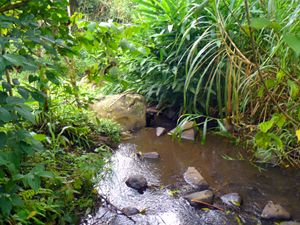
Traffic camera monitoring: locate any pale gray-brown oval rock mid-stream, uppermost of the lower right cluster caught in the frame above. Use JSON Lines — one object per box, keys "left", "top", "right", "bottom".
{"left": 184, "top": 167, "right": 208, "bottom": 191}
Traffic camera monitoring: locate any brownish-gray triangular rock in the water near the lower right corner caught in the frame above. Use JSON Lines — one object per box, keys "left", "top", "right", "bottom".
{"left": 260, "top": 201, "right": 291, "bottom": 220}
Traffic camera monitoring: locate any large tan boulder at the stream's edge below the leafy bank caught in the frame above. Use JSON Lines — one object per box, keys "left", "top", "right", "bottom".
{"left": 89, "top": 93, "right": 147, "bottom": 131}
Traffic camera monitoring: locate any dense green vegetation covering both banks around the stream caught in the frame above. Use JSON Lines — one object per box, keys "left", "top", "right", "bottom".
{"left": 0, "top": 0, "right": 300, "bottom": 224}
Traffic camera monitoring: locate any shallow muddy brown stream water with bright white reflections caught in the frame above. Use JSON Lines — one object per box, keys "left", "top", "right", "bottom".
{"left": 88, "top": 128, "right": 300, "bottom": 225}
